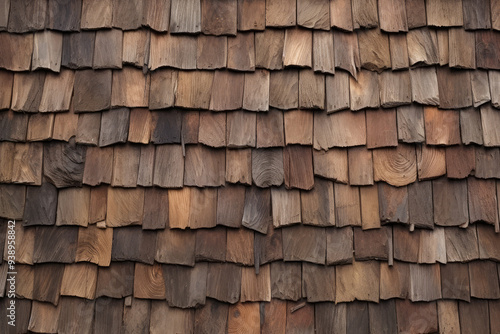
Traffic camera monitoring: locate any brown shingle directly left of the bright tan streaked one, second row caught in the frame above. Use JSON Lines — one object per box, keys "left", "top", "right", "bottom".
{"left": 255, "top": 29, "right": 285, "bottom": 70}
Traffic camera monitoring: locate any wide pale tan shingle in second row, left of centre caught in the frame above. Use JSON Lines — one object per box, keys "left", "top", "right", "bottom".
{"left": 149, "top": 32, "right": 195, "bottom": 70}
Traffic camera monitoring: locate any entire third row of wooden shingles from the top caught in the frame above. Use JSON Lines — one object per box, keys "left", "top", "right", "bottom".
{"left": 0, "top": 58, "right": 500, "bottom": 113}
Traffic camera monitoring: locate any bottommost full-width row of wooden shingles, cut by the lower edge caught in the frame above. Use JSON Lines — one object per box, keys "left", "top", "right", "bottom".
{"left": 1, "top": 297, "right": 500, "bottom": 334}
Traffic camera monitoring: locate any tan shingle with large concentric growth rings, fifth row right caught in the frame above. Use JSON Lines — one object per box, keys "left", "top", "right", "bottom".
{"left": 373, "top": 145, "right": 417, "bottom": 187}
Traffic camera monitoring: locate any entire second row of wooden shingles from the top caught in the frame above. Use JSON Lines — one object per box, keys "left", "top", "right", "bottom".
{"left": 0, "top": 24, "right": 500, "bottom": 76}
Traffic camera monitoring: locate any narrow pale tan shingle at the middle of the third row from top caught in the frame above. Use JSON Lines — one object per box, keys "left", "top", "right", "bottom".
{"left": 243, "top": 70, "right": 270, "bottom": 111}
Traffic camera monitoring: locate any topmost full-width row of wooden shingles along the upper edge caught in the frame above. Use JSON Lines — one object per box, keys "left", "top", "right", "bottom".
{"left": 0, "top": 0, "right": 500, "bottom": 35}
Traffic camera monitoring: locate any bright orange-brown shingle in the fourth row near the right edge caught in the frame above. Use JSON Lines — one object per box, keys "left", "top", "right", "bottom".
{"left": 424, "top": 107, "right": 460, "bottom": 145}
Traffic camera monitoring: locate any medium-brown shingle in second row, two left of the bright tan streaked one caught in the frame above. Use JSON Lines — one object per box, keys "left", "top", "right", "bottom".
{"left": 227, "top": 32, "right": 255, "bottom": 71}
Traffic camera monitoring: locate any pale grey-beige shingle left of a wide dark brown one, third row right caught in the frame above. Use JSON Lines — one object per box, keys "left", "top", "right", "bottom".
{"left": 410, "top": 67, "right": 439, "bottom": 105}
